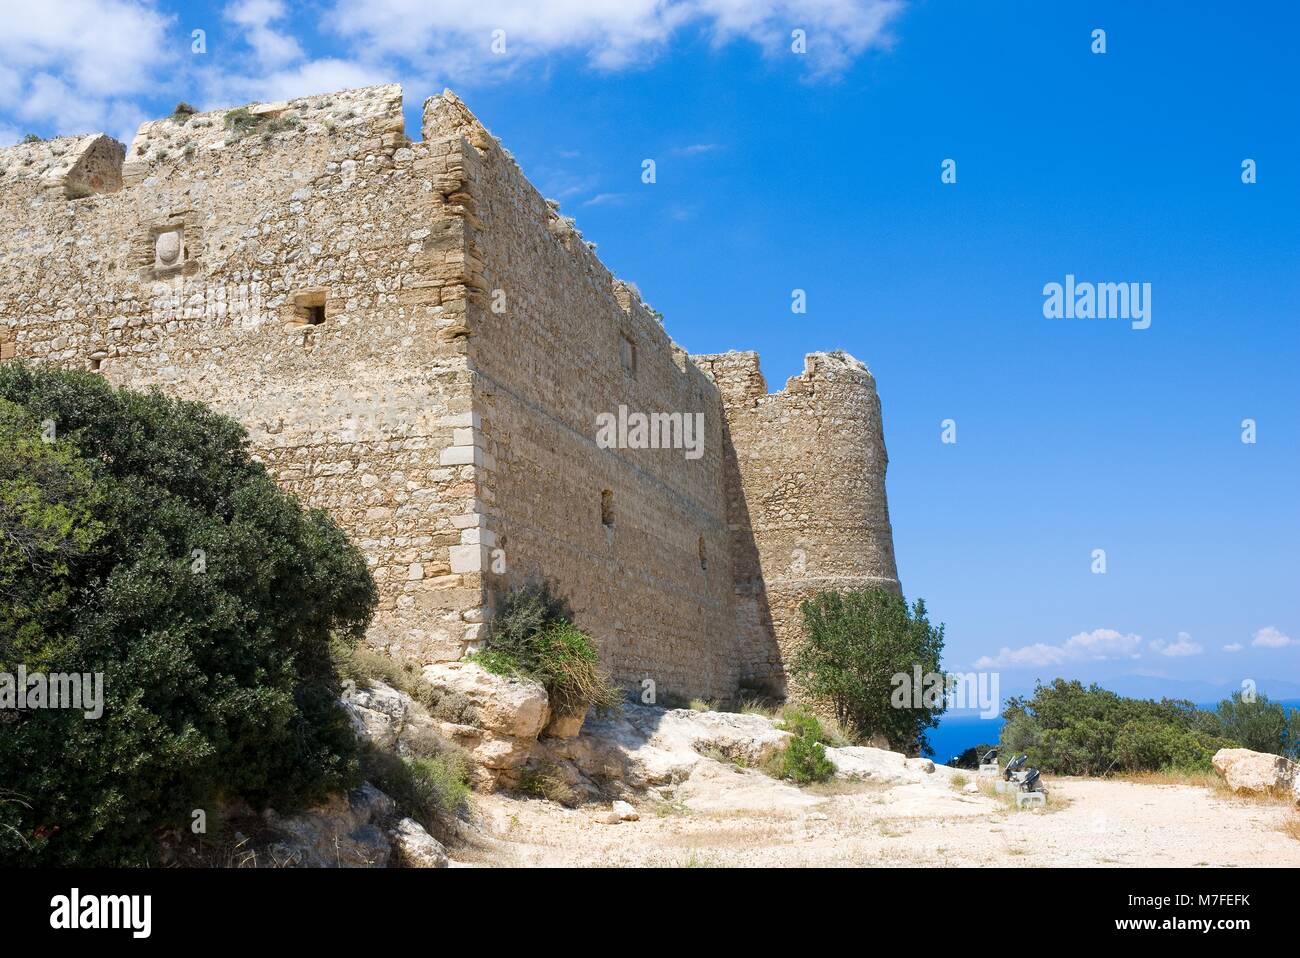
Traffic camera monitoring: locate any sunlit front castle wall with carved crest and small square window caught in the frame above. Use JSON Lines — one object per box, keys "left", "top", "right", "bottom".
{"left": 0, "top": 86, "right": 482, "bottom": 662}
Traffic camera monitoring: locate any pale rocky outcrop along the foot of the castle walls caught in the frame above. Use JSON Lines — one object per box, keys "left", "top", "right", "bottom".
{"left": 345, "top": 662, "right": 972, "bottom": 816}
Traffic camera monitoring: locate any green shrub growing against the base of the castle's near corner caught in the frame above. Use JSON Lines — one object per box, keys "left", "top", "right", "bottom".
{"left": 471, "top": 584, "right": 624, "bottom": 715}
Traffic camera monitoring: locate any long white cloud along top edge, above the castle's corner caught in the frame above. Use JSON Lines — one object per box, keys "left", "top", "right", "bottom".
{"left": 329, "top": 0, "right": 904, "bottom": 81}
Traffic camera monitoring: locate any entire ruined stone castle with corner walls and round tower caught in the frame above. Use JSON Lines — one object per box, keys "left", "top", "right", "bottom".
{"left": 0, "top": 84, "right": 898, "bottom": 699}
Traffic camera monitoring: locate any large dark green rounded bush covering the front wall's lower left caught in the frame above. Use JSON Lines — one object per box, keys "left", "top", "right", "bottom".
{"left": 0, "top": 363, "right": 377, "bottom": 864}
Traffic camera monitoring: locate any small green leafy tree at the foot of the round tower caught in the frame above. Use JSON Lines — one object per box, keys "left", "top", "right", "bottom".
{"left": 790, "top": 589, "right": 944, "bottom": 751}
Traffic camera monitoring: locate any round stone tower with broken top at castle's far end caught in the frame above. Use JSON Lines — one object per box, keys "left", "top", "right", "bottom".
{"left": 692, "top": 352, "right": 898, "bottom": 690}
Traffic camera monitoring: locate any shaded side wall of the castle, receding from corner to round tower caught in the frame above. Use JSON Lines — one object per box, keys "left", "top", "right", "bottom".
{"left": 425, "top": 94, "right": 736, "bottom": 697}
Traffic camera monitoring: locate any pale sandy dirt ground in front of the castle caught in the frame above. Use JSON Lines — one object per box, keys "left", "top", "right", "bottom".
{"left": 451, "top": 762, "right": 1300, "bottom": 868}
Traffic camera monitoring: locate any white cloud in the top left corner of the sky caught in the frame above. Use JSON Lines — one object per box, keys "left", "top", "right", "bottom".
{"left": 0, "top": 0, "right": 176, "bottom": 138}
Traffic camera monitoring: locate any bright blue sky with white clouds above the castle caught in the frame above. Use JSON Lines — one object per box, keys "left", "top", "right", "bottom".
{"left": 0, "top": 0, "right": 1300, "bottom": 701}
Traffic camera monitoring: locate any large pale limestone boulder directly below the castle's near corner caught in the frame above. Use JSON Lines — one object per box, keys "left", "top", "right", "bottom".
{"left": 421, "top": 662, "right": 551, "bottom": 740}
